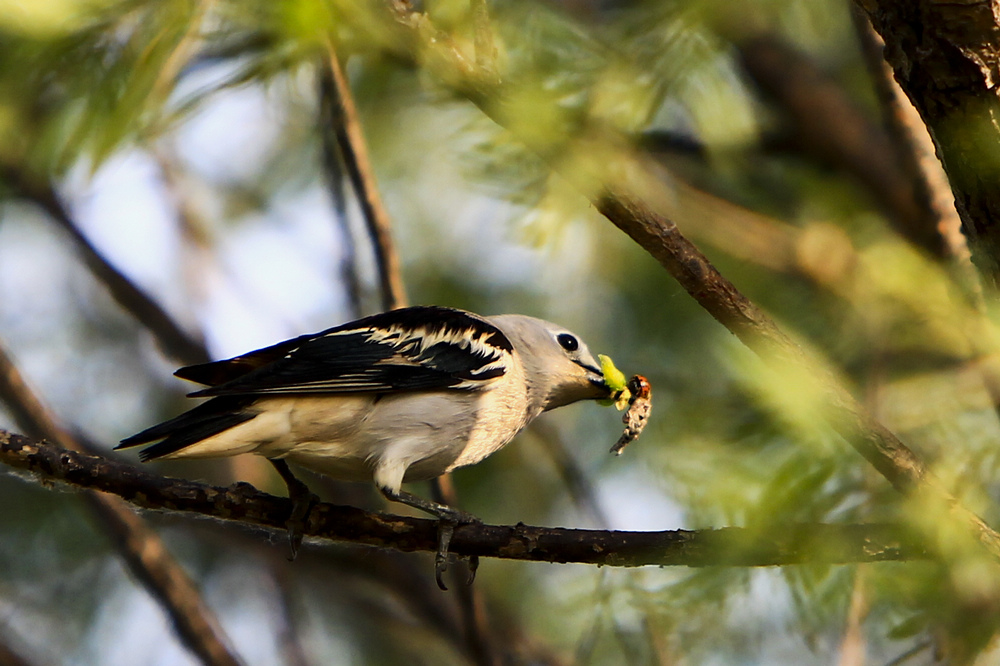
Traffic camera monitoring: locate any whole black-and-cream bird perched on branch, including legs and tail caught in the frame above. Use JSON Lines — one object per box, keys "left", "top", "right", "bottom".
{"left": 116, "top": 306, "right": 611, "bottom": 587}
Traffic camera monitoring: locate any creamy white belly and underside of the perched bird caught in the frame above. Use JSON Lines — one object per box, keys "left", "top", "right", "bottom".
{"left": 165, "top": 358, "right": 537, "bottom": 492}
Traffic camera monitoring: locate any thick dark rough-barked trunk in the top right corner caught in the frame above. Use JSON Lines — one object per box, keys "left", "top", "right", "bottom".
{"left": 859, "top": 0, "right": 1000, "bottom": 287}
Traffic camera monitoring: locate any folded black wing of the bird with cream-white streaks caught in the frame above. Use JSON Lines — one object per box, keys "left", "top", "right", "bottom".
{"left": 177, "top": 306, "right": 513, "bottom": 396}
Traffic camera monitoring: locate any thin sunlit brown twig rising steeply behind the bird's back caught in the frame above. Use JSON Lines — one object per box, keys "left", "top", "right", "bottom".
{"left": 323, "top": 44, "right": 407, "bottom": 310}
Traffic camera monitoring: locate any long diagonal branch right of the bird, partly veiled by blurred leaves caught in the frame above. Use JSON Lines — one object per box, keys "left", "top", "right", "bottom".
{"left": 376, "top": 5, "right": 1000, "bottom": 560}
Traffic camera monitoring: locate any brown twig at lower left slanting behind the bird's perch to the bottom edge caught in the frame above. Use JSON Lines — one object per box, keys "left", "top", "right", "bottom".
{"left": 0, "top": 347, "right": 240, "bottom": 666}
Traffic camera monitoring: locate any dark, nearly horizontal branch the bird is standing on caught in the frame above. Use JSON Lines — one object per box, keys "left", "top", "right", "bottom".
{"left": 0, "top": 430, "right": 929, "bottom": 567}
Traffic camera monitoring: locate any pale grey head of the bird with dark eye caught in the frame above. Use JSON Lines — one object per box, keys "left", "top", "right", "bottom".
{"left": 489, "top": 315, "right": 611, "bottom": 410}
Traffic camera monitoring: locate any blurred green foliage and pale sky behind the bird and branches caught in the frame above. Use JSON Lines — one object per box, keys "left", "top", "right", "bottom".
{"left": 0, "top": 0, "right": 1000, "bottom": 665}
